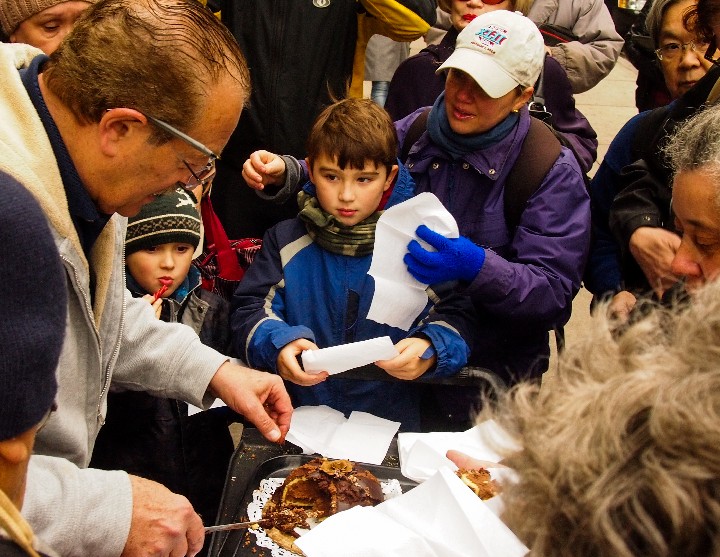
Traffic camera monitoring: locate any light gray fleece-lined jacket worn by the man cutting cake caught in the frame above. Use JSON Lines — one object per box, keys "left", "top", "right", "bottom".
{"left": 0, "top": 44, "right": 227, "bottom": 557}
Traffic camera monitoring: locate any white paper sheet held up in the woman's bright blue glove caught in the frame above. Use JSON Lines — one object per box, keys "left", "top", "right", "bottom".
{"left": 367, "top": 193, "right": 460, "bottom": 331}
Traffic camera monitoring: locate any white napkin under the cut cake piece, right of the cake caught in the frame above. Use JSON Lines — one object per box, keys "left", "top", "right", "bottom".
{"left": 398, "top": 420, "right": 520, "bottom": 482}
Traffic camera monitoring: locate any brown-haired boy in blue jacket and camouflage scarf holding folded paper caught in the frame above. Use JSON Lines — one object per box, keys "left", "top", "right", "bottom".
{"left": 231, "top": 99, "right": 472, "bottom": 430}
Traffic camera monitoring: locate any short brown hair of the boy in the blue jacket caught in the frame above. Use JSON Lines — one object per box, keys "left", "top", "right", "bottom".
{"left": 307, "top": 98, "right": 397, "bottom": 172}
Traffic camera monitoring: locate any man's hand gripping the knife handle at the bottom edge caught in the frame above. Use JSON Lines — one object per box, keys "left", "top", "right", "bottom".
{"left": 122, "top": 476, "right": 204, "bottom": 557}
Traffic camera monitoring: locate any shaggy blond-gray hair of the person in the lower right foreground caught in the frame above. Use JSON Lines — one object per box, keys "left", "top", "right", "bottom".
{"left": 481, "top": 283, "right": 720, "bottom": 557}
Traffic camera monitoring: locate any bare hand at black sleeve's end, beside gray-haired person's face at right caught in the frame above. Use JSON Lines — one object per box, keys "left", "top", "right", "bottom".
{"left": 630, "top": 226, "right": 680, "bottom": 298}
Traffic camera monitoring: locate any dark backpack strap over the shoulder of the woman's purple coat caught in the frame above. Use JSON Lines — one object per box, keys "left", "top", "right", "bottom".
{"left": 504, "top": 118, "right": 560, "bottom": 234}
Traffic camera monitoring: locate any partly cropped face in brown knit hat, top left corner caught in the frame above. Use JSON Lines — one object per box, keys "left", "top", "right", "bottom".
{"left": 0, "top": 0, "right": 96, "bottom": 56}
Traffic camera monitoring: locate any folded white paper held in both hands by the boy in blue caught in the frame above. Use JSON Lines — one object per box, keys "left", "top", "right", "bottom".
{"left": 301, "top": 336, "right": 399, "bottom": 375}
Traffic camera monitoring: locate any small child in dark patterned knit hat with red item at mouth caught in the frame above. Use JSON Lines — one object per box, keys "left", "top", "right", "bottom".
{"left": 91, "top": 188, "right": 234, "bottom": 536}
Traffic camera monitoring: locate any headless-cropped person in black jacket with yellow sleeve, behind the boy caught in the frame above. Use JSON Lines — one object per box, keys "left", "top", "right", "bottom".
{"left": 205, "top": 0, "right": 435, "bottom": 238}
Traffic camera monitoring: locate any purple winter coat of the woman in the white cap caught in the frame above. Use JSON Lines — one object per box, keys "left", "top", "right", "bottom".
{"left": 395, "top": 107, "right": 590, "bottom": 383}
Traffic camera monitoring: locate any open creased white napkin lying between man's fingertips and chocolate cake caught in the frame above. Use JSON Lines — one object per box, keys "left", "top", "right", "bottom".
{"left": 286, "top": 406, "right": 400, "bottom": 464}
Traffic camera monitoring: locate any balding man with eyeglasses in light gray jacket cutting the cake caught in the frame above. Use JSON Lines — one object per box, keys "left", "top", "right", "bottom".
{"left": 0, "top": 0, "right": 292, "bottom": 557}
